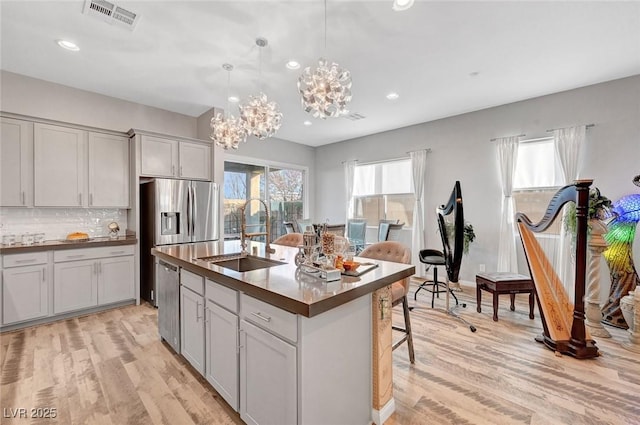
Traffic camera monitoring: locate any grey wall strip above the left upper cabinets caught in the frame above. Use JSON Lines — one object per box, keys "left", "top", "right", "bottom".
{"left": 0, "top": 71, "right": 196, "bottom": 138}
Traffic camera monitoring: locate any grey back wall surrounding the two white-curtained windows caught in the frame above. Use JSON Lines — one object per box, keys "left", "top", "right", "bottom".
{"left": 316, "top": 76, "right": 640, "bottom": 280}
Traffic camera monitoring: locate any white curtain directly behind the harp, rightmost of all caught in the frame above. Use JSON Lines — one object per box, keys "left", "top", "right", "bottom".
{"left": 553, "top": 125, "right": 587, "bottom": 295}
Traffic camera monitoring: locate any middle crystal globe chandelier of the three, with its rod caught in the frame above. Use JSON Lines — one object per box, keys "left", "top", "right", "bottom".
{"left": 240, "top": 38, "right": 282, "bottom": 140}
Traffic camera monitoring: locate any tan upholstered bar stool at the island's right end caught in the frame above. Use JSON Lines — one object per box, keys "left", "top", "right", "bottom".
{"left": 359, "top": 241, "right": 415, "bottom": 363}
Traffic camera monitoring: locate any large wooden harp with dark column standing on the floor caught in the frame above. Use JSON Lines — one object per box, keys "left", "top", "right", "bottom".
{"left": 516, "top": 180, "right": 598, "bottom": 359}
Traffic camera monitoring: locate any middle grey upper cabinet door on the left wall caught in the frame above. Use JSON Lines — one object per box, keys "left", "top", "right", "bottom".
{"left": 34, "top": 123, "right": 87, "bottom": 207}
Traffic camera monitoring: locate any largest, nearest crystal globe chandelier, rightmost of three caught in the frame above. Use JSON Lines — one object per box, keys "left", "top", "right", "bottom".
{"left": 298, "top": 0, "right": 351, "bottom": 119}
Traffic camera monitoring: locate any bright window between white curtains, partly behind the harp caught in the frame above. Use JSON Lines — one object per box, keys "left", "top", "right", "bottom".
{"left": 513, "top": 137, "right": 564, "bottom": 235}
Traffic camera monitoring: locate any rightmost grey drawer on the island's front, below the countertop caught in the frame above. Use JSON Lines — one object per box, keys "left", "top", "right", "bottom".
{"left": 240, "top": 294, "right": 298, "bottom": 342}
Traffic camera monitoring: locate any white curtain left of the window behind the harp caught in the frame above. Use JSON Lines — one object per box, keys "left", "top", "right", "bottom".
{"left": 496, "top": 136, "right": 520, "bottom": 273}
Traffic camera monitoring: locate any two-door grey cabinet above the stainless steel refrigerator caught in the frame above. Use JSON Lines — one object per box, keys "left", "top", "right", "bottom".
{"left": 140, "top": 135, "right": 212, "bottom": 180}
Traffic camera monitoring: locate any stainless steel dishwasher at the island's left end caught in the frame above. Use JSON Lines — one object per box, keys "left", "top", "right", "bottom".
{"left": 156, "top": 260, "right": 180, "bottom": 353}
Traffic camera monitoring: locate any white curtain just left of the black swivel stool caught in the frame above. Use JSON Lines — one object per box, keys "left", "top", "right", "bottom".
{"left": 409, "top": 149, "right": 428, "bottom": 275}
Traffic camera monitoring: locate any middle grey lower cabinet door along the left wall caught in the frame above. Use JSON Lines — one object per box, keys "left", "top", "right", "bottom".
{"left": 53, "top": 260, "right": 98, "bottom": 314}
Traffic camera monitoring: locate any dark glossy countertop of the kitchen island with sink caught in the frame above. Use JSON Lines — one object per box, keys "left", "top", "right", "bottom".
{"left": 151, "top": 241, "right": 415, "bottom": 317}
